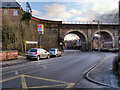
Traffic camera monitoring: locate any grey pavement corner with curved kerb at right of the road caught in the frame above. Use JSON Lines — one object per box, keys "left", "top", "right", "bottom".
{"left": 86, "top": 53, "right": 120, "bottom": 89}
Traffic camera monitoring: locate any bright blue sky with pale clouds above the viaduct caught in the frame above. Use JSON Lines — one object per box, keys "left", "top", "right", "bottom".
{"left": 17, "top": 0, "right": 119, "bottom": 21}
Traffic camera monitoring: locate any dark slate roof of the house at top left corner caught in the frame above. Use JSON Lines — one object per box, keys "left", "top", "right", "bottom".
{"left": 2, "top": 2, "right": 21, "bottom": 8}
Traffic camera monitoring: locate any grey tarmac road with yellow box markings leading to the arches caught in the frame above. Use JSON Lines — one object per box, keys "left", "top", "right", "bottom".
{"left": 0, "top": 51, "right": 115, "bottom": 88}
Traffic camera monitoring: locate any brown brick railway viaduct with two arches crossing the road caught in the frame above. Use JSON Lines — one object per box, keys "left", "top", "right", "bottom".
{"left": 59, "top": 23, "right": 119, "bottom": 50}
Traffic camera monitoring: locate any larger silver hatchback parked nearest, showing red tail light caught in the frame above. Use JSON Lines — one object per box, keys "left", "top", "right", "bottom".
{"left": 26, "top": 48, "right": 50, "bottom": 60}
